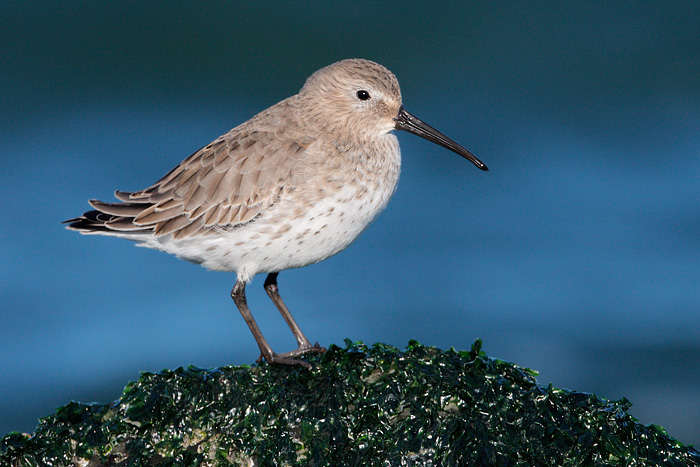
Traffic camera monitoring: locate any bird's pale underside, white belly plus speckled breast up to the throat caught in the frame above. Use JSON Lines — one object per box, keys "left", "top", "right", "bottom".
{"left": 136, "top": 134, "right": 401, "bottom": 281}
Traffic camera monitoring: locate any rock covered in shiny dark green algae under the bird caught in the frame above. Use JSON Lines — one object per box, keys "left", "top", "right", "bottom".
{"left": 0, "top": 341, "right": 700, "bottom": 466}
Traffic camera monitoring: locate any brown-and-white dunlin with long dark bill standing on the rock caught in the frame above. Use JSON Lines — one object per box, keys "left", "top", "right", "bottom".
{"left": 66, "top": 59, "right": 487, "bottom": 367}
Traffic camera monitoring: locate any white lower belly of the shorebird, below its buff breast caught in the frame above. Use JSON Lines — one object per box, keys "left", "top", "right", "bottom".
{"left": 143, "top": 169, "right": 398, "bottom": 281}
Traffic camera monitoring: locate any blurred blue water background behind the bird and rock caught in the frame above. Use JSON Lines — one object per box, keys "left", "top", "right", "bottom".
{"left": 0, "top": 1, "right": 700, "bottom": 444}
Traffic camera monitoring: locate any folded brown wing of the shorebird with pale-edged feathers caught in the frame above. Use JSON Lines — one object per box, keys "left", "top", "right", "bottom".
{"left": 71, "top": 101, "right": 312, "bottom": 238}
